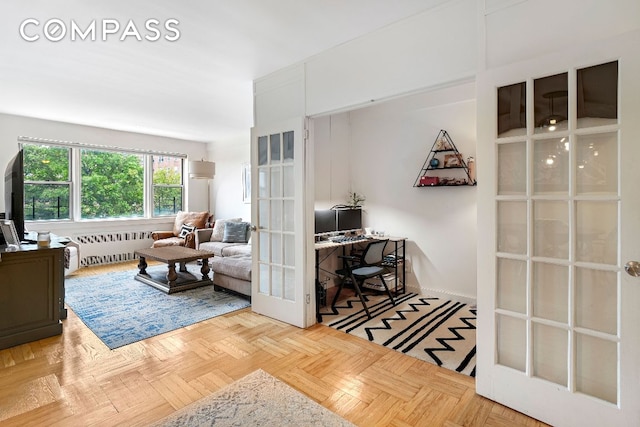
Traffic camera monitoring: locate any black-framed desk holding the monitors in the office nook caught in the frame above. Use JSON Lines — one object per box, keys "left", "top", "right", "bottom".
{"left": 315, "top": 237, "right": 407, "bottom": 323}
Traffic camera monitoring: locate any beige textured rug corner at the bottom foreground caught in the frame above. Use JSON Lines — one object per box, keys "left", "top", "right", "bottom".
{"left": 153, "top": 369, "right": 354, "bottom": 427}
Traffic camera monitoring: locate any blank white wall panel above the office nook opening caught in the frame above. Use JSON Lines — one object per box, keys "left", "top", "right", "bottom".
{"left": 305, "top": 0, "right": 478, "bottom": 115}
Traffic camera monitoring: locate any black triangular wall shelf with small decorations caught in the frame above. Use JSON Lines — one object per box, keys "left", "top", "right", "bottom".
{"left": 413, "top": 130, "right": 476, "bottom": 187}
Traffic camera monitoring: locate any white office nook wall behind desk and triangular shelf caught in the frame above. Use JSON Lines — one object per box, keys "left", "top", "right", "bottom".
{"left": 314, "top": 83, "right": 477, "bottom": 301}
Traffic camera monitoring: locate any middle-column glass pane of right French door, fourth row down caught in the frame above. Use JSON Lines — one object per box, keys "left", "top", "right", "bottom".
{"left": 532, "top": 262, "right": 569, "bottom": 324}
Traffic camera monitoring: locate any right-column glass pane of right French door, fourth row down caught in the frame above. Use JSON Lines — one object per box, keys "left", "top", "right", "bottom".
{"left": 575, "top": 268, "right": 618, "bottom": 335}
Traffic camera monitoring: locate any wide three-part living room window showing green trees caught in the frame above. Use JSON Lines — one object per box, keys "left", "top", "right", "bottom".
{"left": 22, "top": 140, "right": 184, "bottom": 221}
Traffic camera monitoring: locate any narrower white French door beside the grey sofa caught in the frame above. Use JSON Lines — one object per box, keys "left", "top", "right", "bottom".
{"left": 251, "top": 119, "right": 311, "bottom": 327}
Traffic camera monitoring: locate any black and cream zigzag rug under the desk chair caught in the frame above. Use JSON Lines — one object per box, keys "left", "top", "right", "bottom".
{"left": 322, "top": 293, "right": 476, "bottom": 377}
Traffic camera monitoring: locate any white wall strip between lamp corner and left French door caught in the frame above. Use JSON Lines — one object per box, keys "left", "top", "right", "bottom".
{"left": 209, "top": 132, "right": 251, "bottom": 221}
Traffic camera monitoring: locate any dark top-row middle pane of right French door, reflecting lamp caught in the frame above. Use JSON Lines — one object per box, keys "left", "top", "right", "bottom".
{"left": 533, "top": 73, "right": 569, "bottom": 133}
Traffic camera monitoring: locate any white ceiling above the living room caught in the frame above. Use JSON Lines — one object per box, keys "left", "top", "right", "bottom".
{"left": 0, "top": 0, "right": 449, "bottom": 141}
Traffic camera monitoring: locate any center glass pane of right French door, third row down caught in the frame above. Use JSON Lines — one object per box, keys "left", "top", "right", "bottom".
{"left": 533, "top": 200, "right": 569, "bottom": 259}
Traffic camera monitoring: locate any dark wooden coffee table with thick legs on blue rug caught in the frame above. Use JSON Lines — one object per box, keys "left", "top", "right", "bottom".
{"left": 134, "top": 246, "right": 213, "bottom": 294}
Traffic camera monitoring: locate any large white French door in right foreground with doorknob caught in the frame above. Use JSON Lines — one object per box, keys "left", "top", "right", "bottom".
{"left": 476, "top": 32, "right": 640, "bottom": 426}
